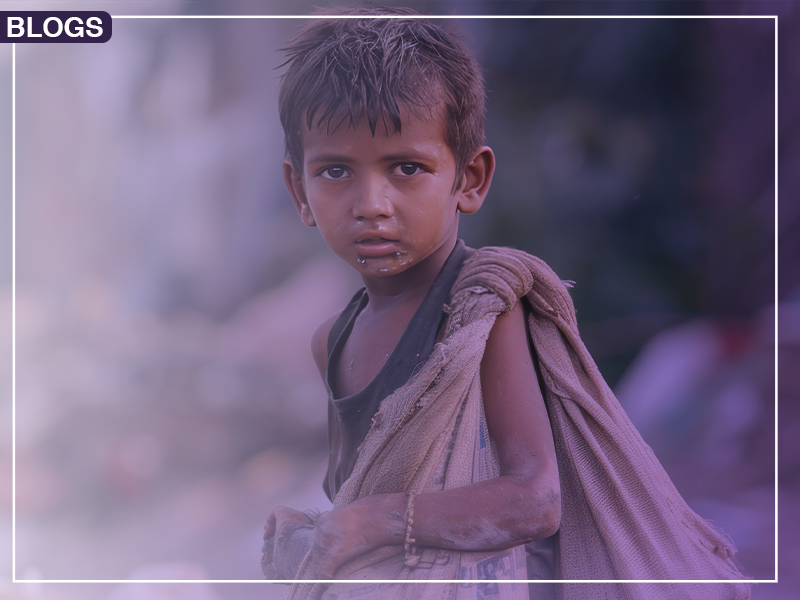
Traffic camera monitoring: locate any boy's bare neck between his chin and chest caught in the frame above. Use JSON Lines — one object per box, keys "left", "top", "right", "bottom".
{"left": 363, "top": 231, "right": 458, "bottom": 312}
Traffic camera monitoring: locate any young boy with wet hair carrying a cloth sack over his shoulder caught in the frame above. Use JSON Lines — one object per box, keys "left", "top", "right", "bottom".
{"left": 262, "top": 9, "right": 749, "bottom": 599}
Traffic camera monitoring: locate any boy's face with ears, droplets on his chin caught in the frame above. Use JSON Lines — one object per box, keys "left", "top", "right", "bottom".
{"left": 284, "top": 111, "right": 494, "bottom": 277}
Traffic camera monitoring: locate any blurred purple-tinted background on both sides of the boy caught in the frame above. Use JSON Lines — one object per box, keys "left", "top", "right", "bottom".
{"left": 0, "top": 1, "right": 800, "bottom": 600}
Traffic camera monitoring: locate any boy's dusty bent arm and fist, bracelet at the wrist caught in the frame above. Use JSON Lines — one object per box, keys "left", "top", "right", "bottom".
{"left": 284, "top": 304, "right": 561, "bottom": 579}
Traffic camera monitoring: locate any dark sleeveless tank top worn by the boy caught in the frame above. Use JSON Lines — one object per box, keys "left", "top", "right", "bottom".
{"left": 322, "top": 240, "right": 472, "bottom": 501}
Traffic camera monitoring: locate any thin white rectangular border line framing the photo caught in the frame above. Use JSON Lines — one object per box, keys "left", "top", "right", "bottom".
{"left": 11, "top": 15, "right": 778, "bottom": 584}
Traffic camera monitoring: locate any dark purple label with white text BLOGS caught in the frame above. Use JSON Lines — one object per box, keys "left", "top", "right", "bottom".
{"left": 0, "top": 10, "right": 111, "bottom": 44}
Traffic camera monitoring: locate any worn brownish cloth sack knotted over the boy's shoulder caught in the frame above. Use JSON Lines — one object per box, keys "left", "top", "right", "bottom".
{"left": 290, "top": 248, "right": 749, "bottom": 600}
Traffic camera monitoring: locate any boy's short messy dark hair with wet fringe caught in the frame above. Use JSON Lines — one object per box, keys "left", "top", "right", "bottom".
{"left": 278, "top": 8, "right": 486, "bottom": 187}
